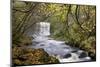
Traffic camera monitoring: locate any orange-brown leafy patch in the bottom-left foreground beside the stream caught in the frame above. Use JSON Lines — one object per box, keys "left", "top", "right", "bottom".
{"left": 13, "top": 47, "right": 59, "bottom": 65}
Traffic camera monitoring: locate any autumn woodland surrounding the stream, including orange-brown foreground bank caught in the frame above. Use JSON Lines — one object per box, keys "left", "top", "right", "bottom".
{"left": 11, "top": 0, "right": 96, "bottom": 65}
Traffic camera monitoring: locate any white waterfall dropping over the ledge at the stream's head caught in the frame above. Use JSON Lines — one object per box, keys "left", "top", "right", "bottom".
{"left": 33, "top": 22, "right": 50, "bottom": 42}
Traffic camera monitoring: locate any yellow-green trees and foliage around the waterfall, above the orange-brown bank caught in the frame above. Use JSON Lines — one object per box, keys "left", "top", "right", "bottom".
{"left": 12, "top": 1, "right": 96, "bottom": 63}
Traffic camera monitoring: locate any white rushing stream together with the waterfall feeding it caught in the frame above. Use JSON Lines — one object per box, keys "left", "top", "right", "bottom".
{"left": 31, "top": 22, "right": 91, "bottom": 63}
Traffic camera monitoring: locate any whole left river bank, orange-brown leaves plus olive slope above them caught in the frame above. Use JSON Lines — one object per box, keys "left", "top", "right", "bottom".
{"left": 12, "top": 36, "right": 59, "bottom": 66}
